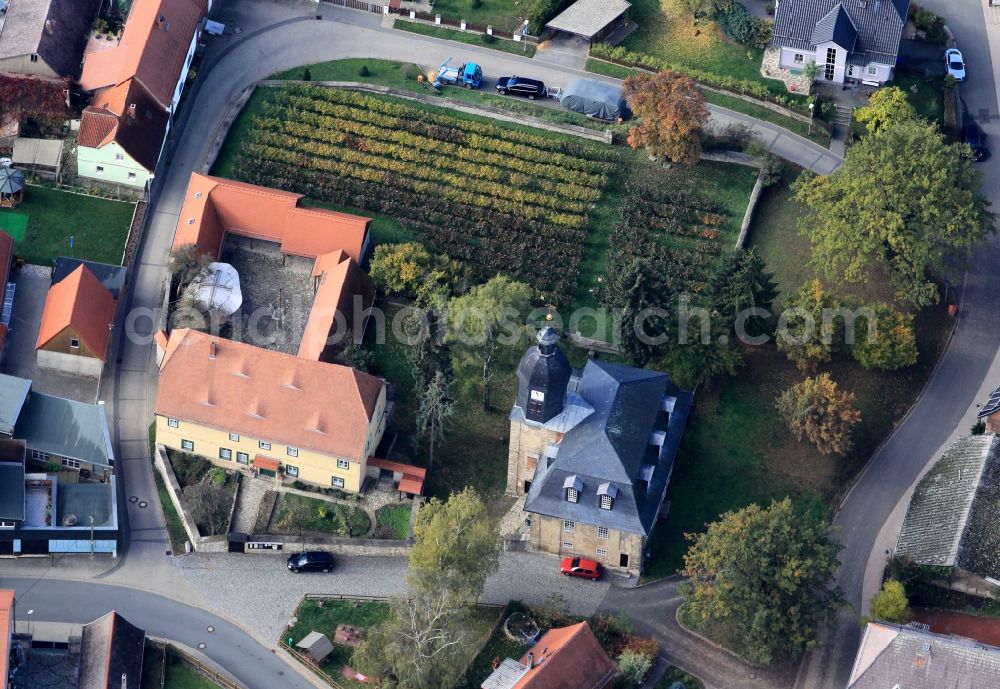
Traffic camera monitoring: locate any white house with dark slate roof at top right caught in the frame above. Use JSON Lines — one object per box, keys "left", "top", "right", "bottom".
{"left": 771, "top": 0, "right": 910, "bottom": 85}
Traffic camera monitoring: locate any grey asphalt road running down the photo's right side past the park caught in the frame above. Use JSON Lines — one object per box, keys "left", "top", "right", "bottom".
{"left": 796, "top": 0, "right": 1000, "bottom": 689}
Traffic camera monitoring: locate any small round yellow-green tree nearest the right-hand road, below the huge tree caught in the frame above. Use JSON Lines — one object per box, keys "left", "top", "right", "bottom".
{"left": 851, "top": 302, "right": 917, "bottom": 371}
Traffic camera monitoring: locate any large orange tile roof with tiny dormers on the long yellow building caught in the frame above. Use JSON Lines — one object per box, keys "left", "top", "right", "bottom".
{"left": 156, "top": 329, "right": 383, "bottom": 462}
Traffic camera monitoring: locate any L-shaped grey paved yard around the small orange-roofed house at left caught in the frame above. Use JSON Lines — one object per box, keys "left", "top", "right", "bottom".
{"left": 0, "top": 265, "right": 98, "bottom": 402}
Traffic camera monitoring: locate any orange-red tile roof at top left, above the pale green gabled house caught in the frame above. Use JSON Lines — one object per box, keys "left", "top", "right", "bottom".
{"left": 80, "top": 0, "right": 205, "bottom": 108}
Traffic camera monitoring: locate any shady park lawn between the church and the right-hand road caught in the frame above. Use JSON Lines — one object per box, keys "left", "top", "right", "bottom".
{"left": 644, "top": 168, "right": 951, "bottom": 579}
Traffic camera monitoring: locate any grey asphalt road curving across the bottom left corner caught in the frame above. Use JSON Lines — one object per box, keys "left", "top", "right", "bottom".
{"left": 0, "top": 577, "right": 314, "bottom": 689}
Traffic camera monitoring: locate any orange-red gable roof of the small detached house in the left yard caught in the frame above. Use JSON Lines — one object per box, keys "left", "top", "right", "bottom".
{"left": 35, "top": 264, "right": 115, "bottom": 361}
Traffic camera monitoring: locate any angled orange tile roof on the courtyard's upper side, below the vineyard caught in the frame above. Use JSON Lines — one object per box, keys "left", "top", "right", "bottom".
{"left": 173, "top": 173, "right": 370, "bottom": 263}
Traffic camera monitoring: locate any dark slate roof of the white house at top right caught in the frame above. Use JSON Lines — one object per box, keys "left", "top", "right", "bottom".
{"left": 771, "top": 0, "right": 910, "bottom": 65}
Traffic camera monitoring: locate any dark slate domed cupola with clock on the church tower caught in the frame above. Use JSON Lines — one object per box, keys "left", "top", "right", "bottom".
{"left": 517, "top": 326, "right": 573, "bottom": 423}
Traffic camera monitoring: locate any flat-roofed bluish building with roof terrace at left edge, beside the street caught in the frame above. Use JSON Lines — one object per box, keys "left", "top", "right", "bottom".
{"left": 0, "top": 438, "right": 120, "bottom": 555}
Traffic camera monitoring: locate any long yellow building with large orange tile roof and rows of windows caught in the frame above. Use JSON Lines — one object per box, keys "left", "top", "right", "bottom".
{"left": 156, "top": 329, "right": 386, "bottom": 492}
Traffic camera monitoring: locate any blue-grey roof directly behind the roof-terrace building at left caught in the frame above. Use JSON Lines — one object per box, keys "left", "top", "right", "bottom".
{"left": 16, "top": 392, "right": 114, "bottom": 467}
